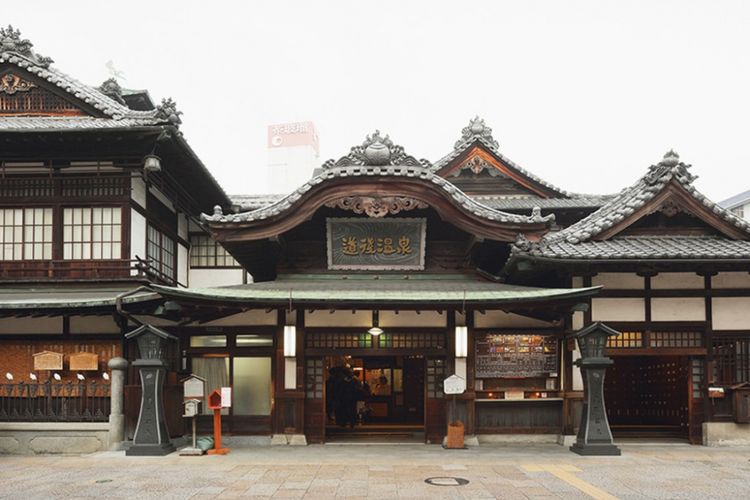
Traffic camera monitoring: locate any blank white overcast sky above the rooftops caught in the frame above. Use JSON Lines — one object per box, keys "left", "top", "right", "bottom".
{"left": 3, "top": 0, "right": 750, "bottom": 201}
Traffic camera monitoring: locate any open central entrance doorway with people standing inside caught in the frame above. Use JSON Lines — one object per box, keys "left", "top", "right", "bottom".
{"left": 324, "top": 355, "right": 425, "bottom": 443}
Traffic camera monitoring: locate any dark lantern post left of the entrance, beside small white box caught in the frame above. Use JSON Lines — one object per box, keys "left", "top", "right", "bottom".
{"left": 125, "top": 325, "right": 177, "bottom": 456}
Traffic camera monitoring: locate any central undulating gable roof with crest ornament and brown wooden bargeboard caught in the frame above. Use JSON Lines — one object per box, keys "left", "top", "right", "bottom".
{"left": 201, "top": 131, "right": 554, "bottom": 241}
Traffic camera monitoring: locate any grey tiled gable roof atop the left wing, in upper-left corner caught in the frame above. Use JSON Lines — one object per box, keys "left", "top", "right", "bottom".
{"left": 0, "top": 26, "right": 179, "bottom": 130}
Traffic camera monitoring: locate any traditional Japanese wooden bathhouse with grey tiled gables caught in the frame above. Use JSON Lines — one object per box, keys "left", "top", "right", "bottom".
{"left": 0, "top": 25, "right": 750, "bottom": 452}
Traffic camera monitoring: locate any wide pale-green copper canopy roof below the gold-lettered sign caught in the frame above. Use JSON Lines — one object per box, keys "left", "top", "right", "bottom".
{"left": 151, "top": 275, "right": 600, "bottom": 304}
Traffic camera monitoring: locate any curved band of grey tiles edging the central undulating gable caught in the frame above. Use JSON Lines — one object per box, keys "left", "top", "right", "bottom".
{"left": 206, "top": 162, "right": 554, "bottom": 224}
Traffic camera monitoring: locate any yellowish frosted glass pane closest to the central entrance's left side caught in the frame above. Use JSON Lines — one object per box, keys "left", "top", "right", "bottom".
{"left": 232, "top": 357, "right": 271, "bottom": 415}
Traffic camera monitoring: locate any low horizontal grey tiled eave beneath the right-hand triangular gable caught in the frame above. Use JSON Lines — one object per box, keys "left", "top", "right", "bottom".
{"left": 524, "top": 236, "right": 750, "bottom": 260}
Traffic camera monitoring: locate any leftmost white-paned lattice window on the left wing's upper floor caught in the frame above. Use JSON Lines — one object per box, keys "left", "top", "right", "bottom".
{"left": 0, "top": 208, "right": 52, "bottom": 260}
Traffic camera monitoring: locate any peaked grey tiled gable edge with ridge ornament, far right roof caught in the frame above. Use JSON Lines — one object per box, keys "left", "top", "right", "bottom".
{"left": 543, "top": 151, "right": 750, "bottom": 244}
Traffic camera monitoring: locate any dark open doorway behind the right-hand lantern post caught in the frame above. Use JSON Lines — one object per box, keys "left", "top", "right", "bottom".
{"left": 604, "top": 356, "right": 692, "bottom": 439}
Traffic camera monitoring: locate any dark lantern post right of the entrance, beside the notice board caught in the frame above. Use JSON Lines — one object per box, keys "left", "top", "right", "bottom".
{"left": 568, "top": 321, "right": 620, "bottom": 455}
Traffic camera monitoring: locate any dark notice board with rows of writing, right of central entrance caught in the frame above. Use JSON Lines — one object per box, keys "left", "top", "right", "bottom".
{"left": 475, "top": 333, "right": 559, "bottom": 378}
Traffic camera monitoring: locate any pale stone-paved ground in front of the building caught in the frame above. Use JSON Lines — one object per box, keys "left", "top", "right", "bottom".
{"left": 0, "top": 445, "right": 750, "bottom": 500}
